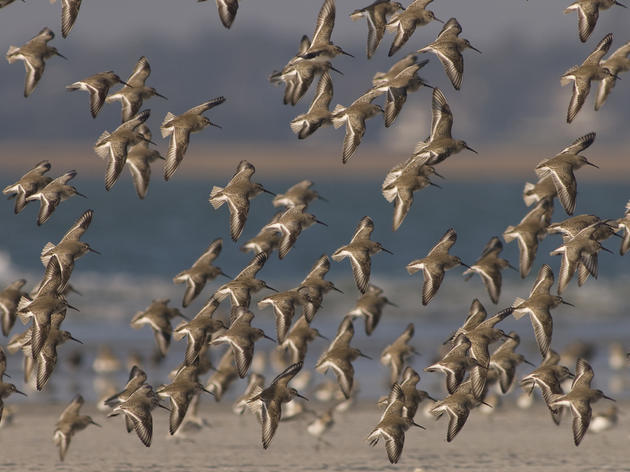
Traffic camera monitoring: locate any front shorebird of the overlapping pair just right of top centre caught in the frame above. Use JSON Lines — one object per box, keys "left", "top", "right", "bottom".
{"left": 366, "top": 55, "right": 432, "bottom": 128}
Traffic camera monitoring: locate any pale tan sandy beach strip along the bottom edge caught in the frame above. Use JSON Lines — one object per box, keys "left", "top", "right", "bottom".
{"left": 0, "top": 402, "right": 630, "bottom": 472}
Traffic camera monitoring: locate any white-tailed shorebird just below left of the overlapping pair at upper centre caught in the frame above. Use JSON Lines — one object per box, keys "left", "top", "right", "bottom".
{"left": 331, "top": 93, "right": 385, "bottom": 164}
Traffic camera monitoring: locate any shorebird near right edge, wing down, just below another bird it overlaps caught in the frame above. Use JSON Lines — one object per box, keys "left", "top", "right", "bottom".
{"left": 550, "top": 222, "right": 612, "bottom": 295}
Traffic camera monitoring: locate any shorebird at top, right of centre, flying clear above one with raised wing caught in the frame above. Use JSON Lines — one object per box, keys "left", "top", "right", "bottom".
{"left": 418, "top": 18, "right": 481, "bottom": 90}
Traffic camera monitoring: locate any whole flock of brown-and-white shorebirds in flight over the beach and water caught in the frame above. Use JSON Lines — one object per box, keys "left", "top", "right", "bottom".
{"left": 0, "top": 0, "right": 630, "bottom": 463}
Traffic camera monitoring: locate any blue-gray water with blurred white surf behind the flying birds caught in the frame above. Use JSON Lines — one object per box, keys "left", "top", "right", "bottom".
{"left": 0, "top": 176, "right": 630, "bottom": 401}
